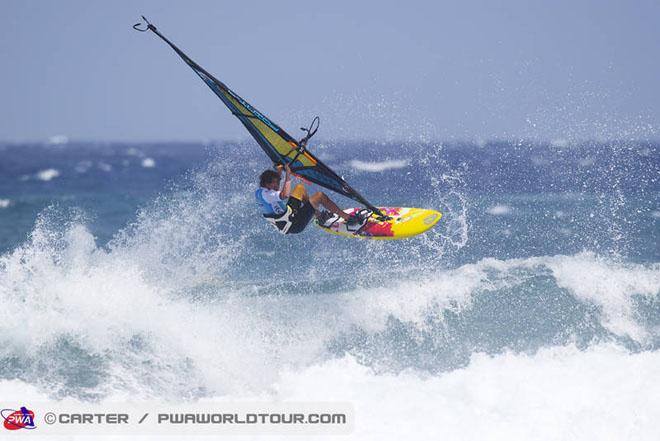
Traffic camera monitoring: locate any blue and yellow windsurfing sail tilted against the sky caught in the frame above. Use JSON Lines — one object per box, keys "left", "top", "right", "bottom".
{"left": 141, "top": 17, "right": 380, "bottom": 214}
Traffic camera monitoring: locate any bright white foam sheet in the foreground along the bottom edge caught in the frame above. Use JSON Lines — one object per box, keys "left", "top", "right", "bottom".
{"left": 0, "top": 345, "right": 660, "bottom": 441}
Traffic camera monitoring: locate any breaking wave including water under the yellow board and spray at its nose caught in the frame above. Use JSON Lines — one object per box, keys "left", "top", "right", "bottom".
{"left": 0, "top": 151, "right": 660, "bottom": 416}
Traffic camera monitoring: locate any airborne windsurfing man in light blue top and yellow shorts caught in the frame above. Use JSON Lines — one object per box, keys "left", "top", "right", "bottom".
{"left": 255, "top": 164, "right": 367, "bottom": 234}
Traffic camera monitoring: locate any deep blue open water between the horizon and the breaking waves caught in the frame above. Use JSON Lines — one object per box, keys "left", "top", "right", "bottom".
{"left": 0, "top": 142, "right": 660, "bottom": 261}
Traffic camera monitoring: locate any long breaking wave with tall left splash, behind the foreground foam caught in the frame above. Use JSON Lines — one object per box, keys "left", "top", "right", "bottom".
{"left": 0, "top": 208, "right": 660, "bottom": 399}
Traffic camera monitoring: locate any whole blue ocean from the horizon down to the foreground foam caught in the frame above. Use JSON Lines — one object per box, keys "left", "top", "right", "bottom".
{"left": 0, "top": 141, "right": 660, "bottom": 435}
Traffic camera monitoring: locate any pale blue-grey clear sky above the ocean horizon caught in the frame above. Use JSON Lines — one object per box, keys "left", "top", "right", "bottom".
{"left": 0, "top": 0, "right": 660, "bottom": 142}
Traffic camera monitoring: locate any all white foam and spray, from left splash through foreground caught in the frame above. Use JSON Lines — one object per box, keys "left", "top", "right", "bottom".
{"left": 0, "top": 164, "right": 660, "bottom": 439}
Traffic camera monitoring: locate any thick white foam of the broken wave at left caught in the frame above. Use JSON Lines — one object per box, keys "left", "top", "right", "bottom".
{"left": 0, "top": 218, "right": 276, "bottom": 394}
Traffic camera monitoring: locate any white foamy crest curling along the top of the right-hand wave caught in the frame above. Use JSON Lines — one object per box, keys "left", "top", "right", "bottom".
{"left": 342, "top": 253, "right": 660, "bottom": 344}
